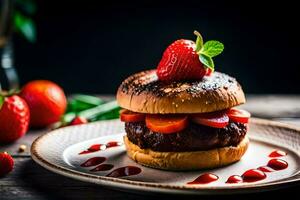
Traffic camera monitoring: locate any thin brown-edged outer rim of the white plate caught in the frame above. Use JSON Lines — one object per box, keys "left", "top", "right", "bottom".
{"left": 30, "top": 118, "right": 300, "bottom": 195}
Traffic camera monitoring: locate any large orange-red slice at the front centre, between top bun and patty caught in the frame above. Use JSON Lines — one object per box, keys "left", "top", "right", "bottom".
{"left": 146, "top": 115, "right": 188, "bottom": 134}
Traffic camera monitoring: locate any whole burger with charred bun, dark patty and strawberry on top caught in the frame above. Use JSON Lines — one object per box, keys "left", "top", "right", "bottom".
{"left": 117, "top": 32, "right": 250, "bottom": 170}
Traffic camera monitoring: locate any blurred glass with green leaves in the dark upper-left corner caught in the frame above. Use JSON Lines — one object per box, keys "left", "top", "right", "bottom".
{"left": 0, "top": 0, "right": 36, "bottom": 90}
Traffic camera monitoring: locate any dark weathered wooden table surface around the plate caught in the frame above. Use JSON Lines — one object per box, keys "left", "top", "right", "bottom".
{"left": 0, "top": 95, "right": 300, "bottom": 200}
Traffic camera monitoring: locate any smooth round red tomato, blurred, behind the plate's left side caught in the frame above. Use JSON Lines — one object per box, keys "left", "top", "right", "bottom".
{"left": 20, "top": 80, "right": 67, "bottom": 127}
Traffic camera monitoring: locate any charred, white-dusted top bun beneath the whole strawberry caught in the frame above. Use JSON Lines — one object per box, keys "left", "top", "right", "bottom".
{"left": 117, "top": 70, "right": 245, "bottom": 114}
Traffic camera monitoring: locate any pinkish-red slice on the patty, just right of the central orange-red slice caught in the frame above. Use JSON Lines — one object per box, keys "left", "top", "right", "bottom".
{"left": 191, "top": 112, "right": 229, "bottom": 128}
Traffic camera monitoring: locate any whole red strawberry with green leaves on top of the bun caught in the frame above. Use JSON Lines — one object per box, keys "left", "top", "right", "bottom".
{"left": 156, "top": 31, "right": 224, "bottom": 81}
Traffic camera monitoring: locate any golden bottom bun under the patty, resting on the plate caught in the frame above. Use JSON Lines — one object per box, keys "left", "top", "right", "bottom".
{"left": 124, "top": 136, "right": 249, "bottom": 170}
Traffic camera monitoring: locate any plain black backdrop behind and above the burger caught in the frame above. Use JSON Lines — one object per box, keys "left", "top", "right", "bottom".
{"left": 15, "top": 0, "right": 300, "bottom": 93}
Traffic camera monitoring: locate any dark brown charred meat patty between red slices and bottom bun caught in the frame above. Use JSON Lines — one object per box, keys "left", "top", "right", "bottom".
{"left": 125, "top": 122, "right": 247, "bottom": 152}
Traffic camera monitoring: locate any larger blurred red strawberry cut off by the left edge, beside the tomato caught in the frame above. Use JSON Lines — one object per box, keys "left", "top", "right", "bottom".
{"left": 0, "top": 94, "right": 30, "bottom": 143}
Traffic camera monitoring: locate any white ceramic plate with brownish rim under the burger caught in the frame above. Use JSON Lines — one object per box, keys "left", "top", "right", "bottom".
{"left": 31, "top": 119, "right": 300, "bottom": 194}
